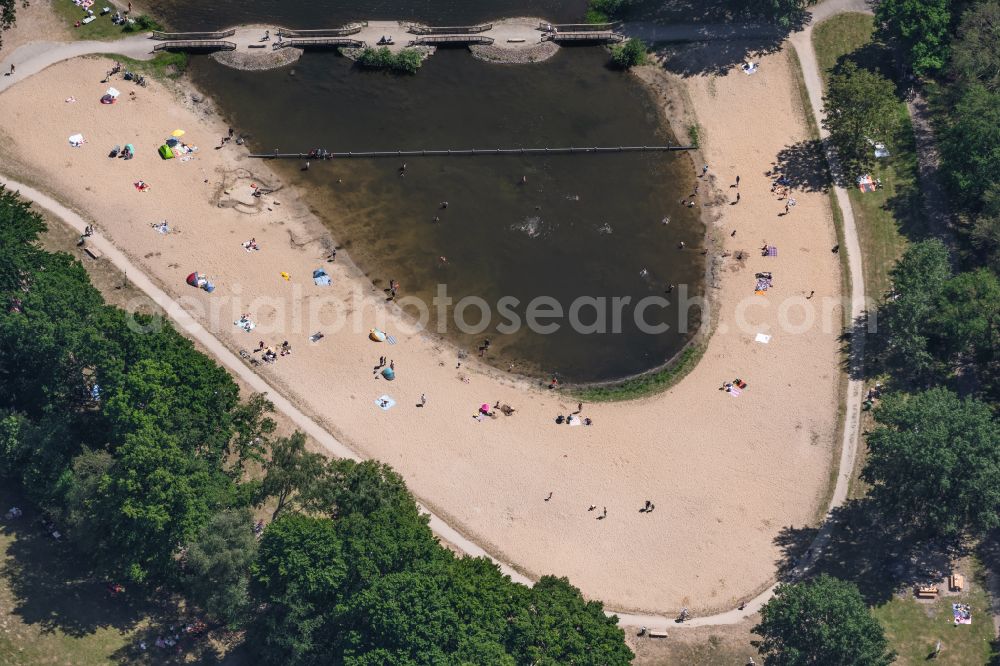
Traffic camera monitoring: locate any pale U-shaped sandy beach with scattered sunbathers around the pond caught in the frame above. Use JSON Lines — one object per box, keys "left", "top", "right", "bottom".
{"left": 0, "top": 53, "right": 842, "bottom": 613}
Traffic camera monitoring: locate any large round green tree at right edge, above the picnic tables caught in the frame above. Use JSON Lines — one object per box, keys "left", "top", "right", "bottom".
{"left": 861, "top": 388, "right": 1000, "bottom": 537}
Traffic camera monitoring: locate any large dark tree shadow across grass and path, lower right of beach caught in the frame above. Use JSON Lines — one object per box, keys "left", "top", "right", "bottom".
{"left": 775, "top": 498, "right": 967, "bottom": 605}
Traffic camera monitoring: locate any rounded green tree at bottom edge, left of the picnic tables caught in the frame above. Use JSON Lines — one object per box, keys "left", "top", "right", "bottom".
{"left": 753, "top": 574, "right": 895, "bottom": 666}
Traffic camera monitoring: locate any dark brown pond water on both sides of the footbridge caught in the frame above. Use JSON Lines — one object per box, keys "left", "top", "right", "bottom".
{"left": 161, "top": 0, "right": 704, "bottom": 381}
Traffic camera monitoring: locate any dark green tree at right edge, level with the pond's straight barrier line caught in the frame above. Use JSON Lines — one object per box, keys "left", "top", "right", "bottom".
{"left": 939, "top": 83, "right": 1000, "bottom": 213}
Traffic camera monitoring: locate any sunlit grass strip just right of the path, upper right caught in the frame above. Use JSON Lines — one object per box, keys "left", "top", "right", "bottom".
{"left": 813, "top": 14, "right": 925, "bottom": 300}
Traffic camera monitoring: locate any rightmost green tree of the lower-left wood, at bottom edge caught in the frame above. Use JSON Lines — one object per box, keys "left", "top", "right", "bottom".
{"left": 510, "top": 576, "right": 635, "bottom": 666}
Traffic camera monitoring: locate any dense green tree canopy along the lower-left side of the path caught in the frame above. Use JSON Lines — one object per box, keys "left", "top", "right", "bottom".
{"left": 0, "top": 185, "right": 632, "bottom": 665}
